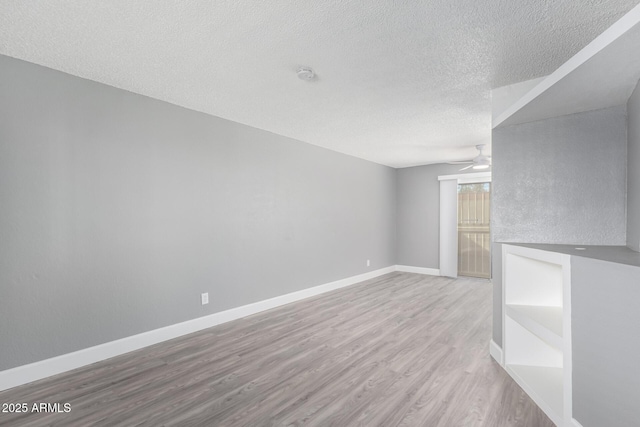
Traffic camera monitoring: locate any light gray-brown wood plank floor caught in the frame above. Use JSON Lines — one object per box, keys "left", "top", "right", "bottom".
{"left": 0, "top": 273, "right": 553, "bottom": 427}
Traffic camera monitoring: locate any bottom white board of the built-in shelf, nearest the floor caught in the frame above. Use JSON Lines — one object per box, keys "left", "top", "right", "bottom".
{"left": 506, "top": 365, "right": 564, "bottom": 425}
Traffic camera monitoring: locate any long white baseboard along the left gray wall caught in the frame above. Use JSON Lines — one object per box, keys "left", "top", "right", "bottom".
{"left": 0, "top": 266, "right": 396, "bottom": 391}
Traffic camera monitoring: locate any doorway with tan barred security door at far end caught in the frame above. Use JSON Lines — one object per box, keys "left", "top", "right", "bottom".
{"left": 458, "top": 182, "right": 491, "bottom": 279}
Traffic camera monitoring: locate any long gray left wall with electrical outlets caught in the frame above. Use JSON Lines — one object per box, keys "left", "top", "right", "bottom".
{"left": 0, "top": 56, "right": 396, "bottom": 369}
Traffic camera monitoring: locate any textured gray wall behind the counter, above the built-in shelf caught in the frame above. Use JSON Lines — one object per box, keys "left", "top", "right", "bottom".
{"left": 491, "top": 106, "right": 627, "bottom": 346}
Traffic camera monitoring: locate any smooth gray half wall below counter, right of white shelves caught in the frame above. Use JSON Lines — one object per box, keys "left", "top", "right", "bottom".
{"left": 571, "top": 257, "right": 640, "bottom": 427}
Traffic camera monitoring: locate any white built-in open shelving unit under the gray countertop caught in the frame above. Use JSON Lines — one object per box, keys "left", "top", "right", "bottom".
{"left": 502, "top": 244, "right": 572, "bottom": 426}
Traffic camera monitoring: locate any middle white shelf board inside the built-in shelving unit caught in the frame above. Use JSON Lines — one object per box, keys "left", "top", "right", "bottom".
{"left": 506, "top": 304, "right": 563, "bottom": 350}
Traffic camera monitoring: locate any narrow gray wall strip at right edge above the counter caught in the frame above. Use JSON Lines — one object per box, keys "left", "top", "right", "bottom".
{"left": 627, "top": 83, "right": 640, "bottom": 251}
